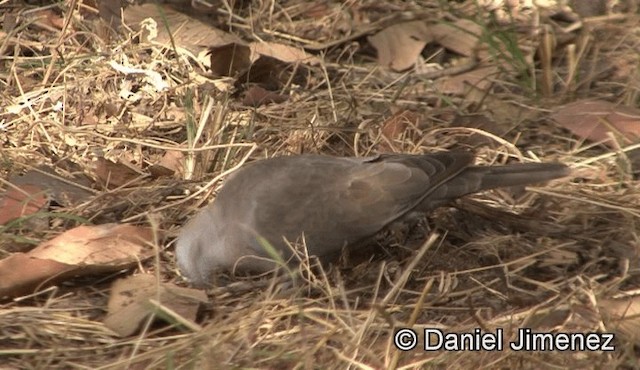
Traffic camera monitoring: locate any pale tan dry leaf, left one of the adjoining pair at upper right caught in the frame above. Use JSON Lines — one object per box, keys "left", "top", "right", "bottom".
{"left": 368, "top": 21, "right": 432, "bottom": 72}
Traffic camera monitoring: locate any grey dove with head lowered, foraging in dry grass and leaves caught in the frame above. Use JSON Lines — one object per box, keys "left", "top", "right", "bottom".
{"left": 176, "top": 151, "right": 569, "bottom": 286}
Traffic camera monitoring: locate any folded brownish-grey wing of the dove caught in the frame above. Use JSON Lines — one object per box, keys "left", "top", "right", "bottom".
{"left": 242, "top": 152, "right": 473, "bottom": 255}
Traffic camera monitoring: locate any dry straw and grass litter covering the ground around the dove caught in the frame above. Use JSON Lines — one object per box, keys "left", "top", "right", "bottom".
{"left": 0, "top": 0, "right": 640, "bottom": 369}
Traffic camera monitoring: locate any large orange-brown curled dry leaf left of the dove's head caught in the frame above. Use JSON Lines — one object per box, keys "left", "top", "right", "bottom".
{"left": 0, "top": 224, "right": 154, "bottom": 297}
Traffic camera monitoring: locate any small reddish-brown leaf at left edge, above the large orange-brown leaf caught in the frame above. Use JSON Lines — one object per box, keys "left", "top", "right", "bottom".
{"left": 0, "top": 184, "right": 49, "bottom": 225}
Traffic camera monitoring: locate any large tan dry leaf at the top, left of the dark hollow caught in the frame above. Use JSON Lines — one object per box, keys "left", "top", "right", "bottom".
{"left": 124, "top": 3, "right": 242, "bottom": 60}
